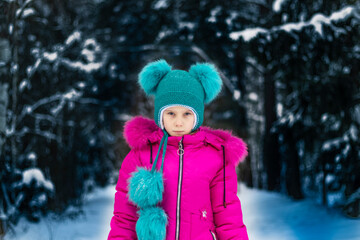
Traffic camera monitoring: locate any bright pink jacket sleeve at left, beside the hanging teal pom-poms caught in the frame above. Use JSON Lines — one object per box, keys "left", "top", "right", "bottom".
{"left": 108, "top": 150, "right": 140, "bottom": 240}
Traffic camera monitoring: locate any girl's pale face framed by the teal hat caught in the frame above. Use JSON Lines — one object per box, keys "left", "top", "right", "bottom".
{"left": 163, "top": 106, "right": 195, "bottom": 137}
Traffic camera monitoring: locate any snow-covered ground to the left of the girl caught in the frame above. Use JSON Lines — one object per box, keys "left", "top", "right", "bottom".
{"left": 5, "top": 186, "right": 115, "bottom": 240}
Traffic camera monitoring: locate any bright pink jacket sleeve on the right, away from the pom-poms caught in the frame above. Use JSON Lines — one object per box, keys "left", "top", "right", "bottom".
{"left": 210, "top": 160, "right": 249, "bottom": 240}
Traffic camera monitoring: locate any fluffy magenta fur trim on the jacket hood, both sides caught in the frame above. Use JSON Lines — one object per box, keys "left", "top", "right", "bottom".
{"left": 124, "top": 116, "right": 248, "bottom": 165}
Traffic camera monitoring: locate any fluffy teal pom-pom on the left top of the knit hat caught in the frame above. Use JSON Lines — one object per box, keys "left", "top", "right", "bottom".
{"left": 139, "top": 59, "right": 171, "bottom": 95}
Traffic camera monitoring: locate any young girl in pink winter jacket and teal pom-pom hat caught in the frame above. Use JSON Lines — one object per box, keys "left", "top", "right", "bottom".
{"left": 108, "top": 60, "right": 248, "bottom": 240}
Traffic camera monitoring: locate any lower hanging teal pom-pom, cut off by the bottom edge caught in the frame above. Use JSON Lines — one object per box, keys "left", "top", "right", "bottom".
{"left": 136, "top": 207, "right": 168, "bottom": 240}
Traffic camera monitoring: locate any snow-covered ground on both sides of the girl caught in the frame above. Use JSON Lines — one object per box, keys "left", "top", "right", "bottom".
{"left": 5, "top": 185, "right": 360, "bottom": 240}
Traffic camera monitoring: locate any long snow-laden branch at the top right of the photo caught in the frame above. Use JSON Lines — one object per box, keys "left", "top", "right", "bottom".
{"left": 230, "top": 3, "right": 355, "bottom": 41}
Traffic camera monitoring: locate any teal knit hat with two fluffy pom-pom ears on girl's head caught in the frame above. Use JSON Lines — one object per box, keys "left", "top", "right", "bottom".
{"left": 139, "top": 59, "right": 222, "bottom": 131}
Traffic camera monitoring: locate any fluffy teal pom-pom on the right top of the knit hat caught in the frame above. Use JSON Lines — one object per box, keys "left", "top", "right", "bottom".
{"left": 189, "top": 63, "right": 222, "bottom": 103}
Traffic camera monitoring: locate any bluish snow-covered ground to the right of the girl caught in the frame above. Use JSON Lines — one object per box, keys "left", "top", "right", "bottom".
{"left": 239, "top": 185, "right": 360, "bottom": 240}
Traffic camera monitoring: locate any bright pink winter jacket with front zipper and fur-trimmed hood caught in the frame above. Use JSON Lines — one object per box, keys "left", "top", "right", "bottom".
{"left": 108, "top": 117, "right": 248, "bottom": 240}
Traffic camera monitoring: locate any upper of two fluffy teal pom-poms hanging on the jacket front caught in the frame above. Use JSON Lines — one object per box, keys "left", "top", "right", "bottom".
{"left": 128, "top": 167, "right": 164, "bottom": 208}
